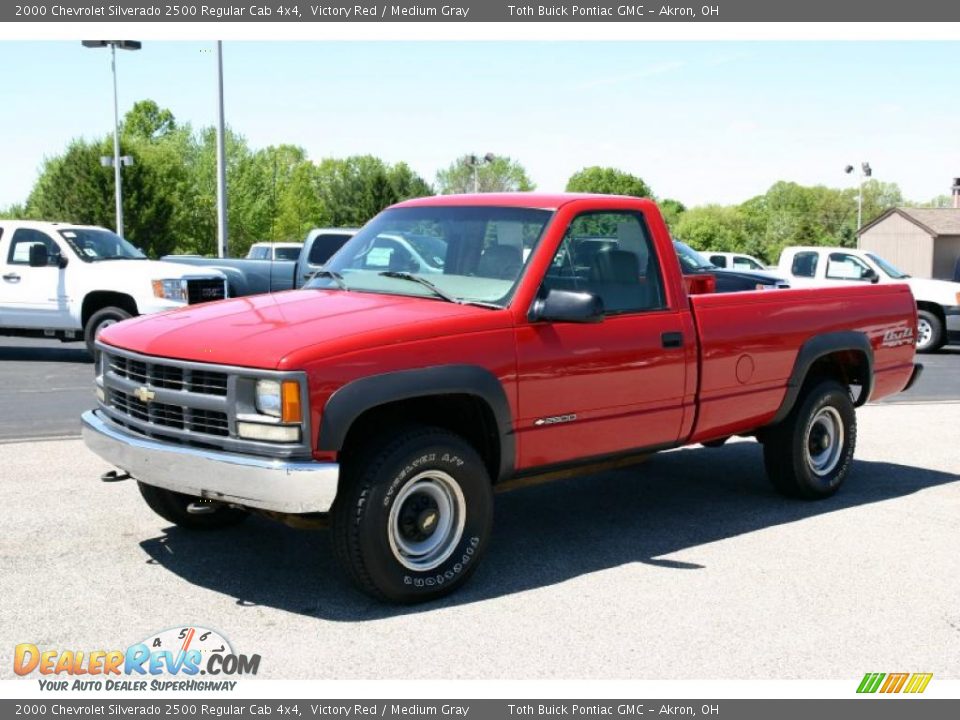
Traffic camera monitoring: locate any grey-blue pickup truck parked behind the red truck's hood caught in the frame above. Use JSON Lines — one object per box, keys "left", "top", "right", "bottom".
{"left": 161, "top": 228, "right": 356, "bottom": 297}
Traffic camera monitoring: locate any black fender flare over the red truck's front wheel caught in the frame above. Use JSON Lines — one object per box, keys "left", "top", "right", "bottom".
{"left": 317, "top": 365, "right": 516, "bottom": 481}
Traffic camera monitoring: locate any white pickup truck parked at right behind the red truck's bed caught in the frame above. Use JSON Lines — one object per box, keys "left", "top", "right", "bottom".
{"left": 779, "top": 247, "right": 960, "bottom": 352}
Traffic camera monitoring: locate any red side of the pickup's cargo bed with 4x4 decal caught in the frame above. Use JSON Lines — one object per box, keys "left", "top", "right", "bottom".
{"left": 690, "top": 284, "right": 916, "bottom": 442}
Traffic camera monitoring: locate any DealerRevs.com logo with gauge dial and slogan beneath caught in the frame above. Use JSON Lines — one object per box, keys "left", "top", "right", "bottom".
{"left": 13, "top": 626, "right": 260, "bottom": 691}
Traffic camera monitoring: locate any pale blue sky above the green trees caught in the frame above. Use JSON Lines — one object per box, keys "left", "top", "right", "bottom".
{"left": 0, "top": 40, "right": 960, "bottom": 208}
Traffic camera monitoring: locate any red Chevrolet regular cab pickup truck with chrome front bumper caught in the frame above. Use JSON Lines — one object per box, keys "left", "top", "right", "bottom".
{"left": 83, "top": 194, "right": 919, "bottom": 602}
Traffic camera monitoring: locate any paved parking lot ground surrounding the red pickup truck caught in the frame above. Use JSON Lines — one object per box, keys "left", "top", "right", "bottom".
{"left": 0, "top": 343, "right": 960, "bottom": 682}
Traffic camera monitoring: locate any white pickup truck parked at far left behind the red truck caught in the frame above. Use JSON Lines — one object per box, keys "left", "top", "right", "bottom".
{"left": 0, "top": 220, "right": 226, "bottom": 352}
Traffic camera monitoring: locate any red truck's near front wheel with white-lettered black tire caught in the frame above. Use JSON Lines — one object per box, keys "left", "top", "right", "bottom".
{"left": 332, "top": 427, "right": 493, "bottom": 603}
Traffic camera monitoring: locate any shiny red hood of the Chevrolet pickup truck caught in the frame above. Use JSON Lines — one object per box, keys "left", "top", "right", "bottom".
{"left": 99, "top": 289, "right": 511, "bottom": 369}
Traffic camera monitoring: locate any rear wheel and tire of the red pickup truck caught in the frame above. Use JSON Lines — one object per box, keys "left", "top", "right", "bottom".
{"left": 763, "top": 380, "right": 857, "bottom": 500}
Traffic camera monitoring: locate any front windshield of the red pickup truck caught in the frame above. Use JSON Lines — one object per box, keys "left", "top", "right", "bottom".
{"left": 306, "top": 207, "right": 553, "bottom": 307}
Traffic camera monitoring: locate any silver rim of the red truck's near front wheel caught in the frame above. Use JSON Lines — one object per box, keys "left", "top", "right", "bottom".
{"left": 387, "top": 470, "right": 467, "bottom": 572}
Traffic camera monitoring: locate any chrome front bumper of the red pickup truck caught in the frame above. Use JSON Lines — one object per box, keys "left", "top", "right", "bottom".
{"left": 80, "top": 410, "right": 340, "bottom": 513}
